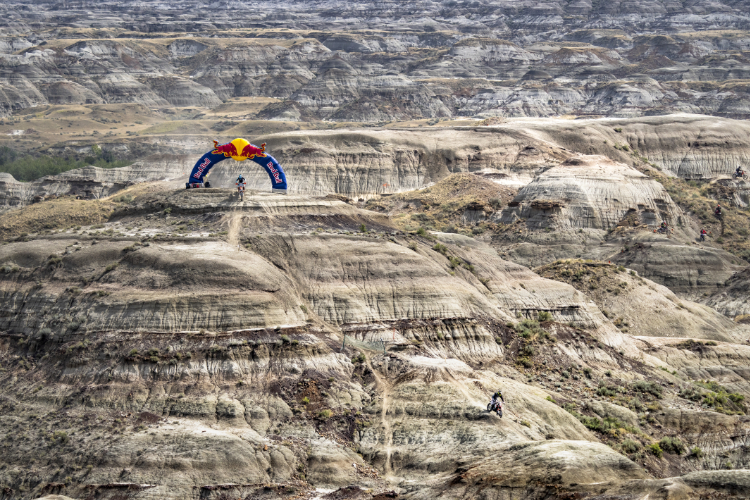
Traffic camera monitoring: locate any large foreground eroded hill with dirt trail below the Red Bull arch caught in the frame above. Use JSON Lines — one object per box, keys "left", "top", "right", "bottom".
{"left": 0, "top": 182, "right": 750, "bottom": 499}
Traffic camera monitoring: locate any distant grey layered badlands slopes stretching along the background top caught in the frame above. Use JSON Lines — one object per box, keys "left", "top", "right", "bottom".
{"left": 0, "top": 0, "right": 750, "bottom": 123}
